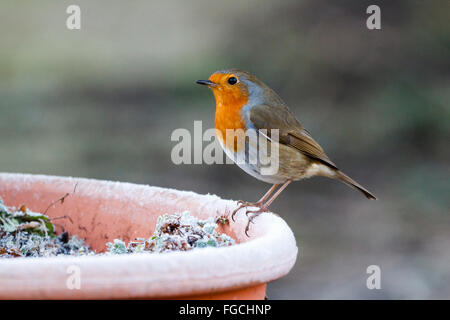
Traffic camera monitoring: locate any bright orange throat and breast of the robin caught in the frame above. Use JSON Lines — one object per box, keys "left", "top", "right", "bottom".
{"left": 214, "top": 90, "right": 248, "bottom": 152}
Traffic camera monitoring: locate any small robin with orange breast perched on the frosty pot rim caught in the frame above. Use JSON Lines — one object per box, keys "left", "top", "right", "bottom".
{"left": 196, "top": 69, "right": 376, "bottom": 236}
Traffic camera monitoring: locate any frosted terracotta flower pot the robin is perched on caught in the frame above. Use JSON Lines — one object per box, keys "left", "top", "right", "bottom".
{"left": 0, "top": 173, "right": 297, "bottom": 299}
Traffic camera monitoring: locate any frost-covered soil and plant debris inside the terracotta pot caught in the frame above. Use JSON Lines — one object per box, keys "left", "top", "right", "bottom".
{"left": 0, "top": 197, "right": 235, "bottom": 258}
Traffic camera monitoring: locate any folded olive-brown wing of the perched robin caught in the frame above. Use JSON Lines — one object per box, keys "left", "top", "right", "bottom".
{"left": 249, "top": 104, "right": 337, "bottom": 169}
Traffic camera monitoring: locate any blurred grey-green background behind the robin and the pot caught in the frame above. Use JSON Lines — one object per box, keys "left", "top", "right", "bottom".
{"left": 0, "top": 0, "right": 450, "bottom": 299}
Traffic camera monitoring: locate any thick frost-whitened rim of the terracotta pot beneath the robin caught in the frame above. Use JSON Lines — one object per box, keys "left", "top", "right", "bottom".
{"left": 0, "top": 173, "right": 298, "bottom": 299}
